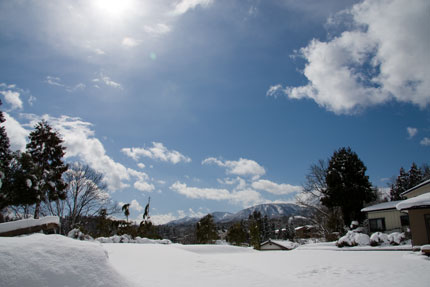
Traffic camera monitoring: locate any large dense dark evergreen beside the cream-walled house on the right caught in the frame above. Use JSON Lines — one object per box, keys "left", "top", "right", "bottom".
{"left": 321, "top": 147, "right": 376, "bottom": 224}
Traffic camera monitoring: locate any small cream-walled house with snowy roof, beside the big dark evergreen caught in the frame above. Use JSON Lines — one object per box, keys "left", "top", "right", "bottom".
{"left": 361, "top": 200, "right": 409, "bottom": 232}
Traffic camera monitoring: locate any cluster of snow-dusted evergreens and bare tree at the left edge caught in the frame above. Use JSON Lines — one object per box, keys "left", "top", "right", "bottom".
{"left": 0, "top": 101, "right": 119, "bottom": 236}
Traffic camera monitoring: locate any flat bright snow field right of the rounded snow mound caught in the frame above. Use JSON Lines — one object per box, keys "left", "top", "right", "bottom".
{"left": 103, "top": 244, "right": 430, "bottom": 287}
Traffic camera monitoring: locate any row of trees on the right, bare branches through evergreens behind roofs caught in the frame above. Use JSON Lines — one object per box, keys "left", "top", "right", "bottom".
{"left": 297, "top": 147, "right": 430, "bottom": 240}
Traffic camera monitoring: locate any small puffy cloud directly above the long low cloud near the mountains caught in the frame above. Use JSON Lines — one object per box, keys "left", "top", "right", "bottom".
{"left": 202, "top": 157, "right": 266, "bottom": 179}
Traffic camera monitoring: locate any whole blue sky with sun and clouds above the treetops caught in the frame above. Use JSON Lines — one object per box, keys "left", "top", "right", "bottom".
{"left": 0, "top": 0, "right": 430, "bottom": 223}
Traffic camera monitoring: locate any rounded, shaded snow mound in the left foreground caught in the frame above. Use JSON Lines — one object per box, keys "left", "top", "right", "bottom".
{"left": 0, "top": 233, "right": 132, "bottom": 287}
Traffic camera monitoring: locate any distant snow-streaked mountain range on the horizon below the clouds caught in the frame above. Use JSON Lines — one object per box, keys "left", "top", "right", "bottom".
{"left": 166, "top": 203, "right": 309, "bottom": 225}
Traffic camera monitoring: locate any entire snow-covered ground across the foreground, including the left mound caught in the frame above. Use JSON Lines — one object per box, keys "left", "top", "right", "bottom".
{"left": 0, "top": 234, "right": 430, "bottom": 287}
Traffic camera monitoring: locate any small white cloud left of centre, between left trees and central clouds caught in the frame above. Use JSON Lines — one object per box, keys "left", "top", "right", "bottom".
{"left": 121, "top": 142, "right": 191, "bottom": 164}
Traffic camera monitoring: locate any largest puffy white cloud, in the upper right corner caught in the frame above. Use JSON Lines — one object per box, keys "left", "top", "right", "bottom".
{"left": 267, "top": 0, "right": 430, "bottom": 114}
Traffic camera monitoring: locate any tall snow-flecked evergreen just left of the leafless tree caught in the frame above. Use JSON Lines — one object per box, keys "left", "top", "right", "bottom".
{"left": 27, "top": 121, "right": 67, "bottom": 218}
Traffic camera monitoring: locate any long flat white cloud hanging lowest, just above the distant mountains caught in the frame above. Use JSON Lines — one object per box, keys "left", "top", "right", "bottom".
{"left": 170, "top": 181, "right": 266, "bottom": 207}
